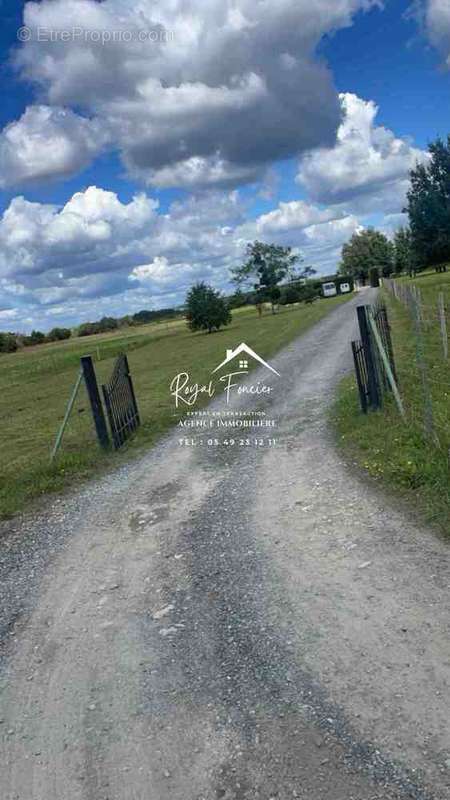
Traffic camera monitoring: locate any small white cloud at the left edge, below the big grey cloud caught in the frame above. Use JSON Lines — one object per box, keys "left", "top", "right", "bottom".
{"left": 0, "top": 105, "right": 106, "bottom": 188}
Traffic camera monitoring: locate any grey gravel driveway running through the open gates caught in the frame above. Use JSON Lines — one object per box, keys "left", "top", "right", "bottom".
{"left": 0, "top": 292, "right": 450, "bottom": 800}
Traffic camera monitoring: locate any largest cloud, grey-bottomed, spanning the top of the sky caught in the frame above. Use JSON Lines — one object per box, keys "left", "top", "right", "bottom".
{"left": 9, "top": 0, "right": 380, "bottom": 187}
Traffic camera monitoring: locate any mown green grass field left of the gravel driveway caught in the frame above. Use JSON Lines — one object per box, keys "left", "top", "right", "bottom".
{"left": 0, "top": 296, "right": 349, "bottom": 517}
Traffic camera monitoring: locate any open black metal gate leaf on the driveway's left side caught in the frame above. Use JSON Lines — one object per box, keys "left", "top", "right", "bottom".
{"left": 102, "top": 354, "right": 140, "bottom": 450}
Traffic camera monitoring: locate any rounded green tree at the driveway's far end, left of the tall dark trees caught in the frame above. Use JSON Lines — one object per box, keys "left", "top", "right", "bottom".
{"left": 339, "top": 228, "right": 394, "bottom": 282}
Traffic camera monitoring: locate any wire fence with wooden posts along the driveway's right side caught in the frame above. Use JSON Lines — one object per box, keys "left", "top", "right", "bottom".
{"left": 383, "top": 279, "right": 450, "bottom": 453}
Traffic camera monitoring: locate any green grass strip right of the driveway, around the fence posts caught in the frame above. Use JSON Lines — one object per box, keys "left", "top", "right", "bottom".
{"left": 334, "top": 272, "right": 450, "bottom": 533}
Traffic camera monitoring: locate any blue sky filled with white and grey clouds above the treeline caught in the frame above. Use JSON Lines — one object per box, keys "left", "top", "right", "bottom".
{"left": 0, "top": 0, "right": 450, "bottom": 332}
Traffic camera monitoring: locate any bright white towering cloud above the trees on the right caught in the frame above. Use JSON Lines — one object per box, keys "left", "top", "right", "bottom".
{"left": 297, "top": 94, "right": 427, "bottom": 213}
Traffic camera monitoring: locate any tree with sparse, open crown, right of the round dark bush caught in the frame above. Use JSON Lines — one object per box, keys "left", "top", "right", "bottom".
{"left": 231, "top": 241, "right": 314, "bottom": 313}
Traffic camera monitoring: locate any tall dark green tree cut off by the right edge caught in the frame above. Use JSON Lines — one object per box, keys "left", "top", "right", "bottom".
{"left": 405, "top": 135, "right": 450, "bottom": 267}
